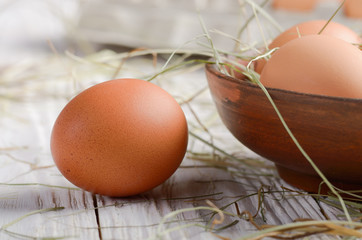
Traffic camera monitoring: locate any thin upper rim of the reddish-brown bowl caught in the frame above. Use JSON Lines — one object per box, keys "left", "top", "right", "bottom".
{"left": 205, "top": 63, "right": 362, "bottom": 104}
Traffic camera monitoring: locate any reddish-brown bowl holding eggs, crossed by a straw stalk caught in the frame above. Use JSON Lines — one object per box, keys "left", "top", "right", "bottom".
{"left": 205, "top": 64, "right": 362, "bottom": 192}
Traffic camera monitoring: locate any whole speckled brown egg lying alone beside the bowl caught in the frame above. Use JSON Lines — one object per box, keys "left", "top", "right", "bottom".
{"left": 51, "top": 79, "right": 188, "bottom": 196}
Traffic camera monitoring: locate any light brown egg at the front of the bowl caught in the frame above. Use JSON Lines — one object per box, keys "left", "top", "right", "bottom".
{"left": 260, "top": 35, "right": 362, "bottom": 98}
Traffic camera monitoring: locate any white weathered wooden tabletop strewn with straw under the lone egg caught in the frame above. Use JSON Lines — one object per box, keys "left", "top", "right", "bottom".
{"left": 0, "top": 0, "right": 360, "bottom": 240}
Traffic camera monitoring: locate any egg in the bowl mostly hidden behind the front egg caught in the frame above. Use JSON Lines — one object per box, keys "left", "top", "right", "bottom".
{"left": 255, "top": 20, "right": 362, "bottom": 74}
